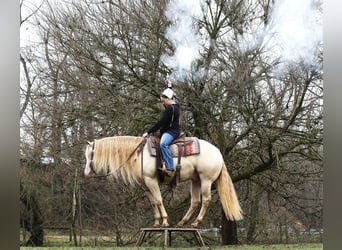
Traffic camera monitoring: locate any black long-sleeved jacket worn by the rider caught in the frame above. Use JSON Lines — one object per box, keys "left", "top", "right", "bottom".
{"left": 147, "top": 103, "right": 180, "bottom": 136}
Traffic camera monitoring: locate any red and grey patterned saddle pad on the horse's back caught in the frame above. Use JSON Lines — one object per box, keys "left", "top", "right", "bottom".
{"left": 147, "top": 137, "right": 200, "bottom": 158}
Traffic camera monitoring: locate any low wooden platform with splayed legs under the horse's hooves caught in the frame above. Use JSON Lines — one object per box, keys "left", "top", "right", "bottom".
{"left": 136, "top": 227, "right": 204, "bottom": 247}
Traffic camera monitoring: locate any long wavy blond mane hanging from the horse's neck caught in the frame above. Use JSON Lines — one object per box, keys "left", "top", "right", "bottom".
{"left": 94, "top": 136, "right": 141, "bottom": 184}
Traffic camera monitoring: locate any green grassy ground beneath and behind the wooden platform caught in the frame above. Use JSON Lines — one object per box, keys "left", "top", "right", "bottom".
{"left": 20, "top": 230, "right": 323, "bottom": 250}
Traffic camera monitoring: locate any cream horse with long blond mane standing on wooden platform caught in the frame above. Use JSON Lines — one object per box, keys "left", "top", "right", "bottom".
{"left": 84, "top": 136, "right": 243, "bottom": 228}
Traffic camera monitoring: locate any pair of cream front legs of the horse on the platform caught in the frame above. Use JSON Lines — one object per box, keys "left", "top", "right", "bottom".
{"left": 145, "top": 178, "right": 169, "bottom": 227}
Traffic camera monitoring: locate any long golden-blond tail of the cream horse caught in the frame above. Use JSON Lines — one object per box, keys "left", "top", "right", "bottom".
{"left": 216, "top": 162, "right": 243, "bottom": 221}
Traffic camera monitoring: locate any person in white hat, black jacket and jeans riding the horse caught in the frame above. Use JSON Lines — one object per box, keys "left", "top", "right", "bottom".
{"left": 143, "top": 79, "right": 180, "bottom": 175}
